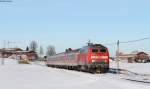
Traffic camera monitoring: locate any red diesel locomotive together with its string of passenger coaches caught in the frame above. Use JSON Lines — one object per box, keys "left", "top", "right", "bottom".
{"left": 46, "top": 43, "right": 109, "bottom": 73}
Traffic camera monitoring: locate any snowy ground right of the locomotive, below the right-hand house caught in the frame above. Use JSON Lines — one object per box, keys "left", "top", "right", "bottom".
{"left": 110, "top": 61, "right": 150, "bottom": 84}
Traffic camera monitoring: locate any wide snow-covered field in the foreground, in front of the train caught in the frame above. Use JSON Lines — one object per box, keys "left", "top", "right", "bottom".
{"left": 0, "top": 59, "right": 150, "bottom": 89}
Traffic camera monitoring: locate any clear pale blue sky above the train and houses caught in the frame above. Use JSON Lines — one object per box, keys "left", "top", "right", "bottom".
{"left": 0, "top": 0, "right": 150, "bottom": 55}
